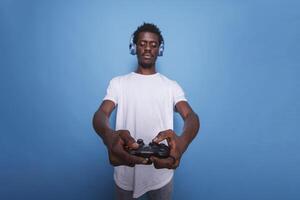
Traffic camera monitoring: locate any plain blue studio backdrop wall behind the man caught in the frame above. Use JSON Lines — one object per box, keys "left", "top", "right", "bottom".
{"left": 0, "top": 0, "right": 300, "bottom": 200}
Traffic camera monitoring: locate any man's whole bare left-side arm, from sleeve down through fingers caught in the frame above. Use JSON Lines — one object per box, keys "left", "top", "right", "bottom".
{"left": 93, "top": 100, "right": 148, "bottom": 167}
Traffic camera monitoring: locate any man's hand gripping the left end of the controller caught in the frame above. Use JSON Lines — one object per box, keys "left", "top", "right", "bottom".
{"left": 106, "top": 130, "right": 148, "bottom": 167}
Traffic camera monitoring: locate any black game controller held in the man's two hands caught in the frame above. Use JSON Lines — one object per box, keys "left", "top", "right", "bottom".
{"left": 128, "top": 139, "right": 170, "bottom": 158}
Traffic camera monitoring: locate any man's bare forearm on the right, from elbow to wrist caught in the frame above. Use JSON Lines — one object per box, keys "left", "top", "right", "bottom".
{"left": 180, "top": 112, "right": 200, "bottom": 151}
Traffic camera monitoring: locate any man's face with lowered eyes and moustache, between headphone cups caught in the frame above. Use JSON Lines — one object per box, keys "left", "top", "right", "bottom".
{"left": 136, "top": 32, "right": 159, "bottom": 68}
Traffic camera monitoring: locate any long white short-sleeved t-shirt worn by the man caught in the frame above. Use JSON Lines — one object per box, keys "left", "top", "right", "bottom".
{"left": 103, "top": 72, "right": 186, "bottom": 198}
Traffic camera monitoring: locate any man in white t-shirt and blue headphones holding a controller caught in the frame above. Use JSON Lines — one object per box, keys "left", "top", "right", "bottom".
{"left": 93, "top": 23, "right": 199, "bottom": 200}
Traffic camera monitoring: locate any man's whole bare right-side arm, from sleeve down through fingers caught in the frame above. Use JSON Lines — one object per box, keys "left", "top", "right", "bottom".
{"left": 151, "top": 101, "right": 200, "bottom": 169}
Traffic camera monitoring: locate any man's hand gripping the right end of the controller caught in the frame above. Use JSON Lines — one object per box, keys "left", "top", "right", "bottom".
{"left": 150, "top": 129, "right": 186, "bottom": 169}
